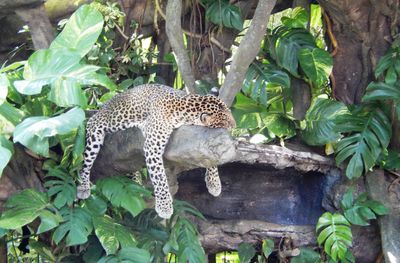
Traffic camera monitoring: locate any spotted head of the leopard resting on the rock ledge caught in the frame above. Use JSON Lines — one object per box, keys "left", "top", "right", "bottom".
{"left": 187, "top": 95, "right": 236, "bottom": 129}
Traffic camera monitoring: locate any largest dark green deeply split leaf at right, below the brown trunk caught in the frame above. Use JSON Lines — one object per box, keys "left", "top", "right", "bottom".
{"left": 335, "top": 107, "right": 391, "bottom": 179}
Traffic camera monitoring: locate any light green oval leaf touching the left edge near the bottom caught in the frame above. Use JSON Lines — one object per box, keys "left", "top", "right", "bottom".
{"left": 0, "top": 189, "right": 49, "bottom": 229}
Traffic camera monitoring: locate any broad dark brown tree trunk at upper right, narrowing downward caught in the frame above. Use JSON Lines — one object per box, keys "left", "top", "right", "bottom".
{"left": 318, "top": 0, "right": 392, "bottom": 104}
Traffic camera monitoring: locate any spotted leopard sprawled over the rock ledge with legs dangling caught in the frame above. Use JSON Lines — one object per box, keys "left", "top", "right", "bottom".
{"left": 77, "top": 84, "right": 236, "bottom": 219}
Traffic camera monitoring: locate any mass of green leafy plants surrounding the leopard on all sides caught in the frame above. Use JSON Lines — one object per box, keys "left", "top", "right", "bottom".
{"left": 0, "top": 0, "right": 400, "bottom": 262}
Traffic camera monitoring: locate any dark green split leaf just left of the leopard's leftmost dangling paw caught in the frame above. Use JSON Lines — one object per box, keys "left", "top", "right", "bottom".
{"left": 44, "top": 169, "right": 76, "bottom": 208}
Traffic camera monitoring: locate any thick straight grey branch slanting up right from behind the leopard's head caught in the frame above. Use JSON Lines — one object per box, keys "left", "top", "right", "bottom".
{"left": 220, "top": 0, "right": 276, "bottom": 106}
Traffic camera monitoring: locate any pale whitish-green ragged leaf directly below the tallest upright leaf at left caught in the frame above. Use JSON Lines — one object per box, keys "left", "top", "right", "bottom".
{"left": 14, "top": 48, "right": 99, "bottom": 95}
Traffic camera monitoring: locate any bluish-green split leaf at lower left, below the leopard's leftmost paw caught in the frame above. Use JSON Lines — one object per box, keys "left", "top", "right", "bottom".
{"left": 53, "top": 207, "right": 93, "bottom": 246}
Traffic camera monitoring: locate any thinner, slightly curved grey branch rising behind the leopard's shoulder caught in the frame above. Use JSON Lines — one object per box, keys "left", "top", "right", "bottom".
{"left": 165, "top": 0, "right": 196, "bottom": 93}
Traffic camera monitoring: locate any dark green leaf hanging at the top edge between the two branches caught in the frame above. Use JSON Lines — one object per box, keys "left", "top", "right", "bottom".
{"left": 206, "top": 0, "right": 243, "bottom": 31}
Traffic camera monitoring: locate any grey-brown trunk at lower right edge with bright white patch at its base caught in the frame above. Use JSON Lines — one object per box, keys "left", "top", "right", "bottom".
{"left": 367, "top": 170, "right": 400, "bottom": 262}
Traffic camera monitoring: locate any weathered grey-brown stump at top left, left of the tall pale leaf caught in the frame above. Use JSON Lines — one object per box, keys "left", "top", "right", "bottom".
{"left": 16, "top": 5, "right": 54, "bottom": 49}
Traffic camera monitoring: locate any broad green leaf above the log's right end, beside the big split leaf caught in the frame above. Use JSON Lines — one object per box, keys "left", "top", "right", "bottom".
{"left": 301, "top": 98, "right": 348, "bottom": 145}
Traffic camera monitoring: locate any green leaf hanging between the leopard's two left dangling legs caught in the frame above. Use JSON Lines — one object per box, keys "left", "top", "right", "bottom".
{"left": 96, "top": 176, "right": 151, "bottom": 216}
